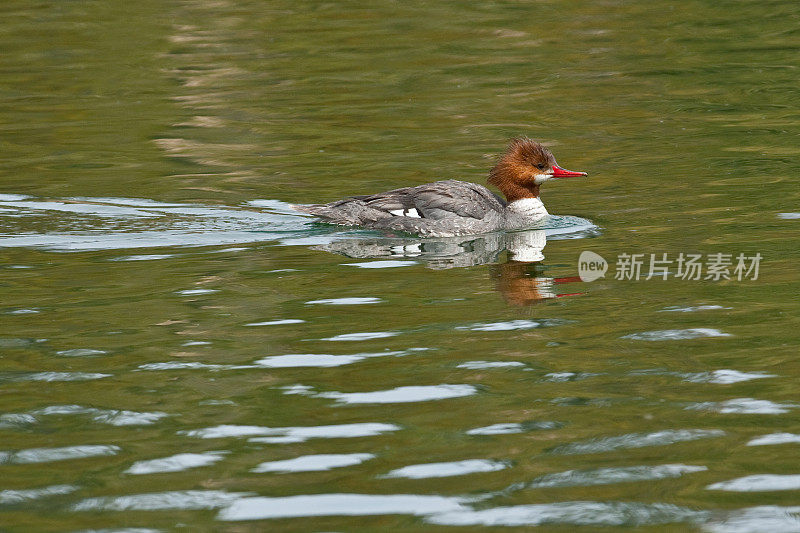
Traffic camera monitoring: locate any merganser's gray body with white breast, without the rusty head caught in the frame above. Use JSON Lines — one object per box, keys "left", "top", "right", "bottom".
{"left": 295, "top": 180, "right": 547, "bottom": 237}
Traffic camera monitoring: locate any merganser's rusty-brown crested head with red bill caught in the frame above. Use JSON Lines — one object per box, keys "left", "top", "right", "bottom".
{"left": 489, "top": 137, "right": 586, "bottom": 203}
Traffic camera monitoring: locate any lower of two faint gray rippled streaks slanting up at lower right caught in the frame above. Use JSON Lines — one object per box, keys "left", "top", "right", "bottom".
{"left": 520, "top": 464, "right": 708, "bottom": 488}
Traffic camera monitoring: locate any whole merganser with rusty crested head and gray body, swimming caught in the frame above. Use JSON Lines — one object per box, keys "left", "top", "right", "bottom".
{"left": 295, "top": 137, "right": 586, "bottom": 237}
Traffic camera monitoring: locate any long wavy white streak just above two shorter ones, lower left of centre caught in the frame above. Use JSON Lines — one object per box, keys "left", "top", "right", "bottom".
{"left": 178, "top": 422, "right": 402, "bottom": 443}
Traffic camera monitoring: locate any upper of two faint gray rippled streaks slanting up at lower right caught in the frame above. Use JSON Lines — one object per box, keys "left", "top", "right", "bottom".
{"left": 548, "top": 429, "right": 725, "bottom": 455}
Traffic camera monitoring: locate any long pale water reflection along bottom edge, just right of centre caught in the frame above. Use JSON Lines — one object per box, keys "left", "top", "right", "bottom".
{"left": 426, "top": 501, "right": 708, "bottom": 527}
